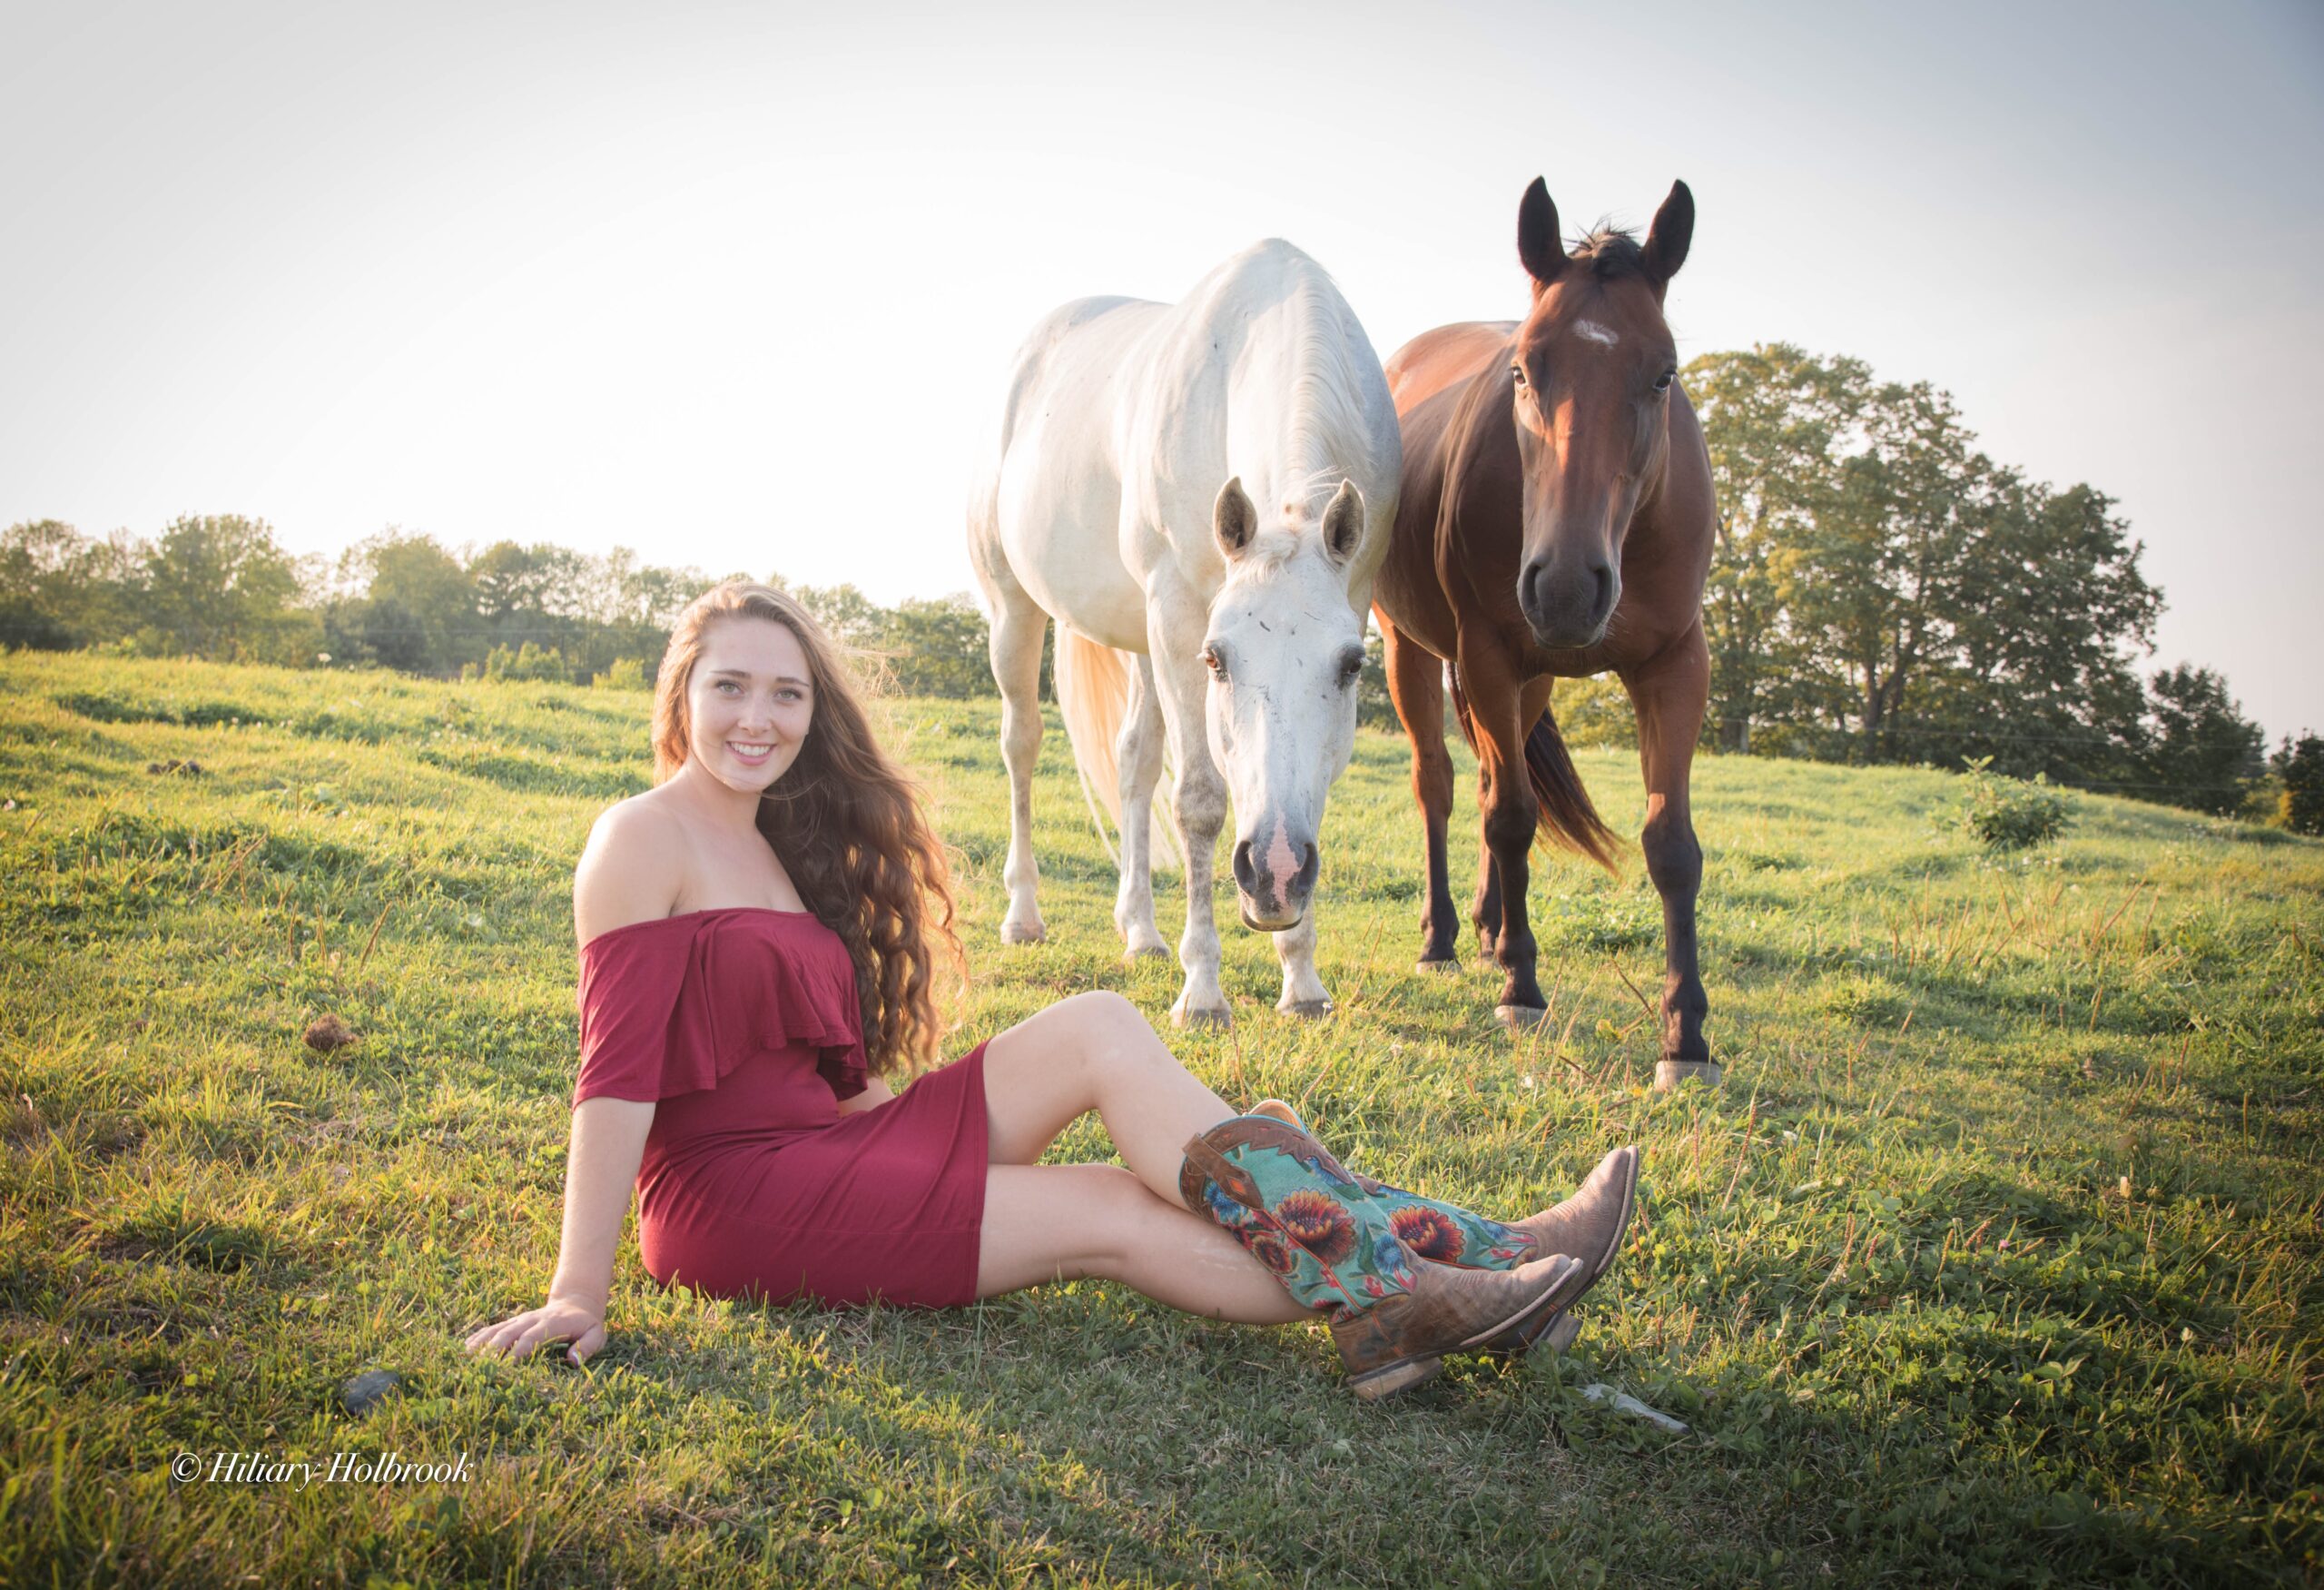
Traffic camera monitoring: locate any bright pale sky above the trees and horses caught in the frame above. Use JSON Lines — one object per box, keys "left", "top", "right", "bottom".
{"left": 0, "top": 0, "right": 2324, "bottom": 737}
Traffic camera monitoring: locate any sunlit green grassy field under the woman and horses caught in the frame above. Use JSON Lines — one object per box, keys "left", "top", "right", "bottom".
{"left": 0, "top": 653, "right": 2324, "bottom": 1585}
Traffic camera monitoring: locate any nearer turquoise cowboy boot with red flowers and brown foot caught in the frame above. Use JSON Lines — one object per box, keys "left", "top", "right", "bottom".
{"left": 1178, "top": 1116, "right": 1581, "bottom": 1399}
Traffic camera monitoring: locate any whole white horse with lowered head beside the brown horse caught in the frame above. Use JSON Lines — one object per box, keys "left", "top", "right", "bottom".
{"left": 970, "top": 240, "right": 1403, "bottom": 1025}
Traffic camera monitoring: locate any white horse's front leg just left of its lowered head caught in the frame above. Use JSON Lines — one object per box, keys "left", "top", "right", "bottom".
{"left": 1146, "top": 590, "right": 1232, "bottom": 1027}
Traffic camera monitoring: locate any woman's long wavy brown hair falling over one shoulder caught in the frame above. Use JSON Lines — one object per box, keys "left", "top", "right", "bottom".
{"left": 653, "top": 578, "right": 967, "bottom": 1076}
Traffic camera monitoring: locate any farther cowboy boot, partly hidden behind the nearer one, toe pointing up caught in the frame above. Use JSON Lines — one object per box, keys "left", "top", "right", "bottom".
{"left": 1253, "top": 1100, "right": 1639, "bottom": 1353}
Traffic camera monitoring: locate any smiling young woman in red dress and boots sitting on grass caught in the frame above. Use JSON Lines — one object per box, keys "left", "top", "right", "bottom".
{"left": 468, "top": 584, "right": 1639, "bottom": 1397}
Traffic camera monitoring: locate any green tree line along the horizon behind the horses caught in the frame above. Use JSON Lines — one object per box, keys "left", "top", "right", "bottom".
{"left": 0, "top": 344, "right": 2324, "bottom": 830}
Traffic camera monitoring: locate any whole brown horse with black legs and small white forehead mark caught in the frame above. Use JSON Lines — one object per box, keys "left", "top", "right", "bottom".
{"left": 1374, "top": 179, "right": 1719, "bottom": 1088}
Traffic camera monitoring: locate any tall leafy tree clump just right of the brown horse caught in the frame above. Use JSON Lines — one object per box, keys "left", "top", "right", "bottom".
{"left": 1688, "top": 344, "right": 2162, "bottom": 784}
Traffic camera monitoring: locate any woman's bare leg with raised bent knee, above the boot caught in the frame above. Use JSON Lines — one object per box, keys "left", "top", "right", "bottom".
{"left": 985, "top": 993, "right": 1241, "bottom": 1199}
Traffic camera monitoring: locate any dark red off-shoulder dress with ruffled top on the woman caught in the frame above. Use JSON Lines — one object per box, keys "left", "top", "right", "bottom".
{"left": 574, "top": 906, "right": 985, "bottom": 1309}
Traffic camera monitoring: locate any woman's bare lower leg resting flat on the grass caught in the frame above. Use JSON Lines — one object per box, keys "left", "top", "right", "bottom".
{"left": 976, "top": 1161, "right": 1315, "bottom": 1325}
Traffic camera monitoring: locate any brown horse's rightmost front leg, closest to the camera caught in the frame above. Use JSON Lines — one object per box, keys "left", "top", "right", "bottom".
{"left": 1622, "top": 621, "right": 1719, "bottom": 1088}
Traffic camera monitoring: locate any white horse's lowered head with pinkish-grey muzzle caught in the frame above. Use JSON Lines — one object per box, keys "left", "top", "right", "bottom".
{"left": 1202, "top": 479, "right": 1364, "bottom": 933}
